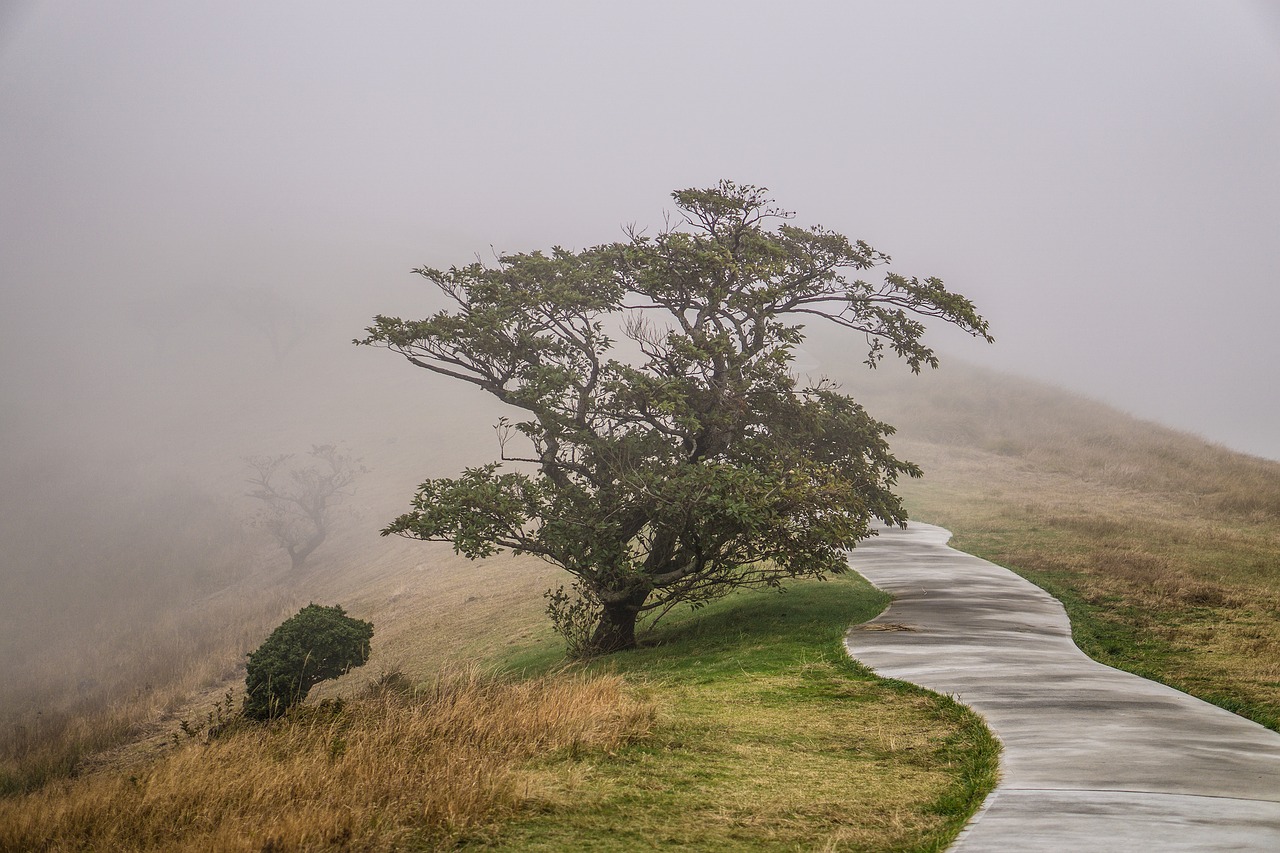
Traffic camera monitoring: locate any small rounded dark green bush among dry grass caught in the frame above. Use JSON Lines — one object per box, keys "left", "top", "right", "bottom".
{"left": 244, "top": 605, "right": 374, "bottom": 720}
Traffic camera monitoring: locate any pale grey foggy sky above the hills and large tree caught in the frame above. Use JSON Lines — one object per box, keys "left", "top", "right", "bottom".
{"left": 0, "top": 0, "right": 1280, "bottom": 459}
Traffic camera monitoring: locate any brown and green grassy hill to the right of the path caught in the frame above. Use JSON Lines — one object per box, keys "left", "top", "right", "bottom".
{"left": 850, "top": 365, "right": 1280, "bottom": 729}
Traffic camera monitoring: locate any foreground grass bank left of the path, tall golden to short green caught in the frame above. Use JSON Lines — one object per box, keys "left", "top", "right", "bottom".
{"left": 0, "top": 560, "right": 997, "bottom": 853}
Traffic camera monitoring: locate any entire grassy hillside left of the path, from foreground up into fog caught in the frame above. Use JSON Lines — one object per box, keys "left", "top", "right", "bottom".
{"left": 0, "top": 350, "right": 996, "bottom": 850}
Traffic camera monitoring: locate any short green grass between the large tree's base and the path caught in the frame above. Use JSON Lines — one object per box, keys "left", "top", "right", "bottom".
{"left": 471, "top": 568, "right": 998, "bottom": 850}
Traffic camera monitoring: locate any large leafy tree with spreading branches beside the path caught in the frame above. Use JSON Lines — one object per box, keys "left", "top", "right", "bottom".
{"left": 356, "top": 181, "right": 992, "bottom": 653}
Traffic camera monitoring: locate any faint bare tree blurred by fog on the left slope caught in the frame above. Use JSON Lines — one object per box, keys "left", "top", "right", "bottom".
{"left": 244, "top": 444, "right": 365, "bottom": 569}
